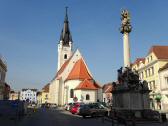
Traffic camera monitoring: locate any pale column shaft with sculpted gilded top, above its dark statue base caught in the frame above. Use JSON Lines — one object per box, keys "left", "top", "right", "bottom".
{"left": 120, "top": 10, "right": 132, "bottom": 67}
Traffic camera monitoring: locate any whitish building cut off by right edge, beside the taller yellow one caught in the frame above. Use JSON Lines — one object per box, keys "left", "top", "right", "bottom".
{"left": 159, "top": 63, "right": 168, "bottom": 111}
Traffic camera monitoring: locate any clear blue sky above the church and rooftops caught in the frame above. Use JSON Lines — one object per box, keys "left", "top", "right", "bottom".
{"left": 0, "top": 0, "right": 168, "bottom": 90}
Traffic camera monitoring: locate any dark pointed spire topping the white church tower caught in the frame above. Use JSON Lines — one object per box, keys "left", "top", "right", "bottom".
{"left": 60, "top": 7, "right": 72, "bottom": 46}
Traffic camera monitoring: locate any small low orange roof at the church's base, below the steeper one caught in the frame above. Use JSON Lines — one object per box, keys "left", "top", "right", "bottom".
{"left": 75, "top": 79, "right": 98, "bottom": 90}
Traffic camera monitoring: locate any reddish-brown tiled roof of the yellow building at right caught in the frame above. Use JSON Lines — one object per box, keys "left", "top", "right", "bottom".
{"left": 148, "top": 46, "right": 168, "bottom": 59}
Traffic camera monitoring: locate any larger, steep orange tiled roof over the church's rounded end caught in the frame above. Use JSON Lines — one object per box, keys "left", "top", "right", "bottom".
{"left": 66, "top": 58, "right": 92, "bottom": 80}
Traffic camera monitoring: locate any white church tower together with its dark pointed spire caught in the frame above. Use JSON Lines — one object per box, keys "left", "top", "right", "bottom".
{"left": 57, "top": 7, "right": 72, "bottom": 71}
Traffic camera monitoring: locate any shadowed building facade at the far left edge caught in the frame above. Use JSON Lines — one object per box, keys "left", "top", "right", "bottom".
{"left": 0, "top": 57, "right": 7, "bottom": 100}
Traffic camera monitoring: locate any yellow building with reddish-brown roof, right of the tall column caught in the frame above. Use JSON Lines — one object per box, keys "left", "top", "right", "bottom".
{"left": 132, "top": 46, "right": 168, "bottom": 109}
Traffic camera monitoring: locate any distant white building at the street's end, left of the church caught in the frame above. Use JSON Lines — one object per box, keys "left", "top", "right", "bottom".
{"left": 20, "top": 89, "right": 37, "bottom": 103}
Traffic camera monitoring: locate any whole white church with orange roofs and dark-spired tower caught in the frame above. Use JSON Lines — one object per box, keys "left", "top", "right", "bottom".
{"left": 49, "top": 9, "right": 102, "bottom": 105}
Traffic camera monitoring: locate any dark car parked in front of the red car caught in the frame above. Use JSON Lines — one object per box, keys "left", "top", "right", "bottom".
{"left": 79, "top": 103, "right": 108, "bottom": 118}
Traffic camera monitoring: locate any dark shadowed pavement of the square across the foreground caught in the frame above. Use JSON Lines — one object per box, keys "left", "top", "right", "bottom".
{"left": 0, "top": 109, "right": 168, "bottom": 126}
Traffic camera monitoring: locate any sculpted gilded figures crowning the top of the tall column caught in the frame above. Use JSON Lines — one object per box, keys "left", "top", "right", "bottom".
{"left": 120, "top": 10, "right": 132, "bottom": 34}
